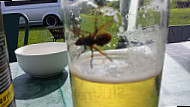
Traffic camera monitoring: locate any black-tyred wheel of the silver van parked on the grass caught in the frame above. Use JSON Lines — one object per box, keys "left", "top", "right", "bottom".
{"left": 44, "top": 15, "right": 59, "bottom": 26}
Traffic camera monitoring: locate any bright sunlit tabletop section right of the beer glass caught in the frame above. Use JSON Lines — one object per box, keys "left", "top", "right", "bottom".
{"left": 160, "top": 42, "right": 190, "bottom": 107}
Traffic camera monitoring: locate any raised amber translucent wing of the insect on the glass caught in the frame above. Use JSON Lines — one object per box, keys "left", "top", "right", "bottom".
{"left": 96, "top": 19, "right": 114, "bottom": 35}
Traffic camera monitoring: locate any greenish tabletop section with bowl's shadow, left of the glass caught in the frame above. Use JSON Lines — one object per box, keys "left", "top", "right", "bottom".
{"left": 10, "top": 62, "right": 72, "bottom": 107}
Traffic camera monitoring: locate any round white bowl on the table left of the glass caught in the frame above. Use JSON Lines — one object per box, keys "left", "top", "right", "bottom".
{"left": 15, "top": 42, "right": 68, "bottom": 77}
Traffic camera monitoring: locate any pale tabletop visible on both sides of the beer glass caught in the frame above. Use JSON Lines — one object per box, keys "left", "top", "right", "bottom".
{"left": 10, "top": 42, "right": 190, "bottom": 107}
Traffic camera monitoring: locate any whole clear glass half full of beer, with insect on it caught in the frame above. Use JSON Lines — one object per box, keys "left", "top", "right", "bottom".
{"left": 62, "top": 0, "right": 169, "bottom": 107}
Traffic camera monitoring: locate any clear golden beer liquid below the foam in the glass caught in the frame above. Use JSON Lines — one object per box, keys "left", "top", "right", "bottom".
{"left": 71, "top": 75, "right": 158, "bottom": 107}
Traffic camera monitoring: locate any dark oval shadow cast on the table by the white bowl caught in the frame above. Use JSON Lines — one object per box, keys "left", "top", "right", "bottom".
{"left": 13, "top": 71, "right": 68, "bottom": 100}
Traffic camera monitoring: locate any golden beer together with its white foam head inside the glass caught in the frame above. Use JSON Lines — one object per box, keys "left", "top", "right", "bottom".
{"left": 70, "top": 48, "right": 161, "bottom": 107}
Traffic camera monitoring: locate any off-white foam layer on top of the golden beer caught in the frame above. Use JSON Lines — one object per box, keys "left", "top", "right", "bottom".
{"left": 70, "top": 46, "right": 162, "bottom": 83}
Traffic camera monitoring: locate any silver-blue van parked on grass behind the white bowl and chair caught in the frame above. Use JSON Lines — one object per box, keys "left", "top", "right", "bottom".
{"left": 1, "top": 0, "right": 63, "bottom": 26}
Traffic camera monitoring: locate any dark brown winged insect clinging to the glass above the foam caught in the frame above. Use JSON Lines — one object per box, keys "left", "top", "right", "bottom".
{"left": 74, "top": 19, "right": 114, "bottom": 68}
